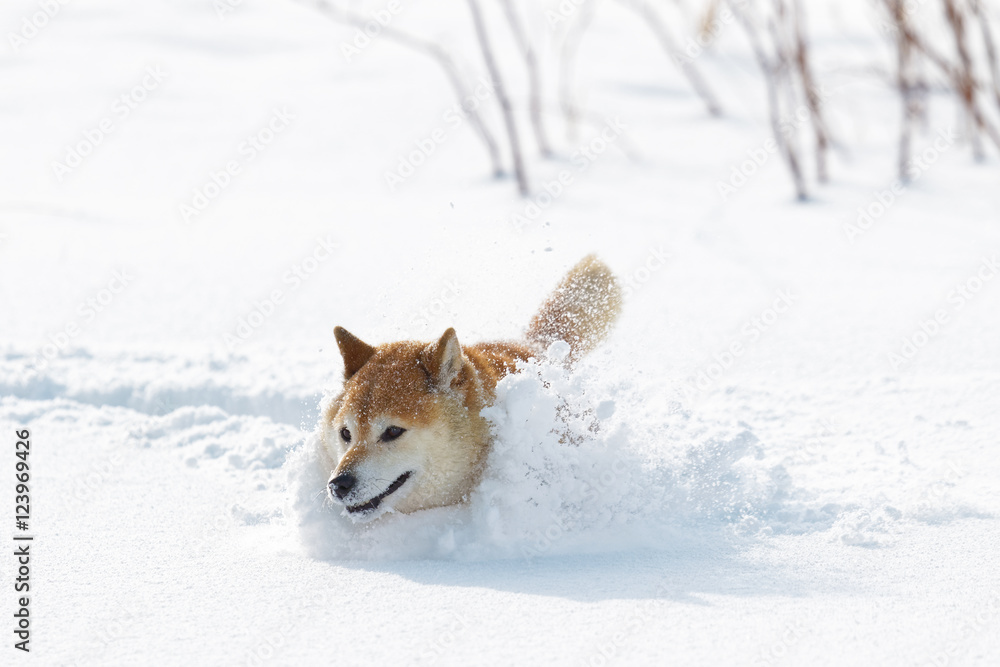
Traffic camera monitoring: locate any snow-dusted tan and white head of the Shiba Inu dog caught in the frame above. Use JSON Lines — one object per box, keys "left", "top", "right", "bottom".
{"left": 321, "top": 327, "right": 487, "bottom": 519}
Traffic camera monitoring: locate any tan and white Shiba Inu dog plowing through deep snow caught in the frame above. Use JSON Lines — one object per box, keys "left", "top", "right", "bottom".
{"left": 319, "top": 255, "right": 622, "bottom": 520}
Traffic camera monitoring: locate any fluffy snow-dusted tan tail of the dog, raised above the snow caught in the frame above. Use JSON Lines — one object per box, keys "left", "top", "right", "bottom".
{"left": 526, "top": 255, "right": 622, "bottom": 362}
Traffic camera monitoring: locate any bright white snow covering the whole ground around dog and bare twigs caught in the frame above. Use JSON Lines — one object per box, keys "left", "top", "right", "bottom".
{"left": 0, "top": 0, "right": 1000, "bottom": 666}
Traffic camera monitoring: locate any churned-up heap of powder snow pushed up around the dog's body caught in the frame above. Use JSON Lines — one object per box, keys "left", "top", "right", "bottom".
{"left": 288, "top": 352, "right": 804, "bottom": 559}
